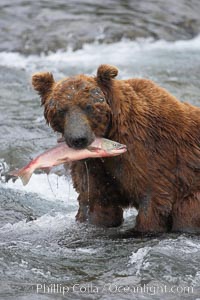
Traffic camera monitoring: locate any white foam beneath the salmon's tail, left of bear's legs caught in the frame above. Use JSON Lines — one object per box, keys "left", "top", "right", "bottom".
{"left": 0, "top": 174, "right": 78, "bottom": 236}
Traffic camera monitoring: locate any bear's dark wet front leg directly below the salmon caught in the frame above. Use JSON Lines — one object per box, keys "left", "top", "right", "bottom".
{"left": 71, "top": 159, "right": 123, "bottom": 227}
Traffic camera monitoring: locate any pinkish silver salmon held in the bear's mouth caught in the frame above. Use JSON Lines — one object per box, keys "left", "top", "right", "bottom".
{"left": 9, "top": 138, "right": 127, "bottom": 185}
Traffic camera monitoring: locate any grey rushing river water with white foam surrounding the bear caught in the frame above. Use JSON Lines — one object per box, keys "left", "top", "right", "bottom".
{"left": 0, "top": 0, "right": 200, "bottom": 300}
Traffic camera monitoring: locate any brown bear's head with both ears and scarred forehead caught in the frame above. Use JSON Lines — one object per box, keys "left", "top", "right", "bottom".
{"left": 32, "top": 65, "right": 118, "bottom": 149}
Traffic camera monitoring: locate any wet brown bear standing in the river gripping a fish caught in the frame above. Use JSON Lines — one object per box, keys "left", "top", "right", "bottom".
{"left": 32, "top": 65, "right": 200, "bottom": 233}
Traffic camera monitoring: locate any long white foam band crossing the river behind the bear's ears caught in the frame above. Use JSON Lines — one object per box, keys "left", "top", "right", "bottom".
{"left": 0, "top": 35, "right": 200, "bottom": 75}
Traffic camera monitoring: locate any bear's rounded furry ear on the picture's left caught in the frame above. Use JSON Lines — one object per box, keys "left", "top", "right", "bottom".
{"left": 32, "top": 72, "right": 55, "bottom": 104}
